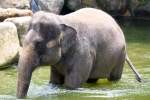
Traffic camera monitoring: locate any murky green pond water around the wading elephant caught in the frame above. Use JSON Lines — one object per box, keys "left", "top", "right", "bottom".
{"left": 0, "top": 20, "right": 150, "bottom": 100}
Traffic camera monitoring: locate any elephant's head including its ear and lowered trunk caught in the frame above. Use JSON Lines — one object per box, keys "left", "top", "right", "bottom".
{"left": 17, "top": 12, "right": 76, "bottom": 98}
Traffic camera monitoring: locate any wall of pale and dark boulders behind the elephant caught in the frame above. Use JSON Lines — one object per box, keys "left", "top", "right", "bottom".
{"left": 0, "top": 0, "right": 150, "bottom": 68}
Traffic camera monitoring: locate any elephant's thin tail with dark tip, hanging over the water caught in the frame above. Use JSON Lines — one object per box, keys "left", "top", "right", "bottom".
{"left": 126, "top": 54, "right": 142, "bottom": 82}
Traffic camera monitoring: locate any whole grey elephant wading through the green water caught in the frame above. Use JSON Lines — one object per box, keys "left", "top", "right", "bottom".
{"left": 16, "top": 8, "right": 141, "bottom": 98}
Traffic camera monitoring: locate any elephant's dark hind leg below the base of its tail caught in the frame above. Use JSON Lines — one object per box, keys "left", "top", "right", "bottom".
{"left": 108, "top": 52, "right": 125, "bottom": 81}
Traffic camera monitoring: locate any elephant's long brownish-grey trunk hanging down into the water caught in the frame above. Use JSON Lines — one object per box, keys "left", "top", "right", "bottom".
{"left": 17, "top": 45, "right": 39, "bottom": 98}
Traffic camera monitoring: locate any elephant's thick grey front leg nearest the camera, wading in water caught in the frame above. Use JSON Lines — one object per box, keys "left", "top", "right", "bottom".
{"left": 64, "top": 48, "right": 93, "bottom": 89}
